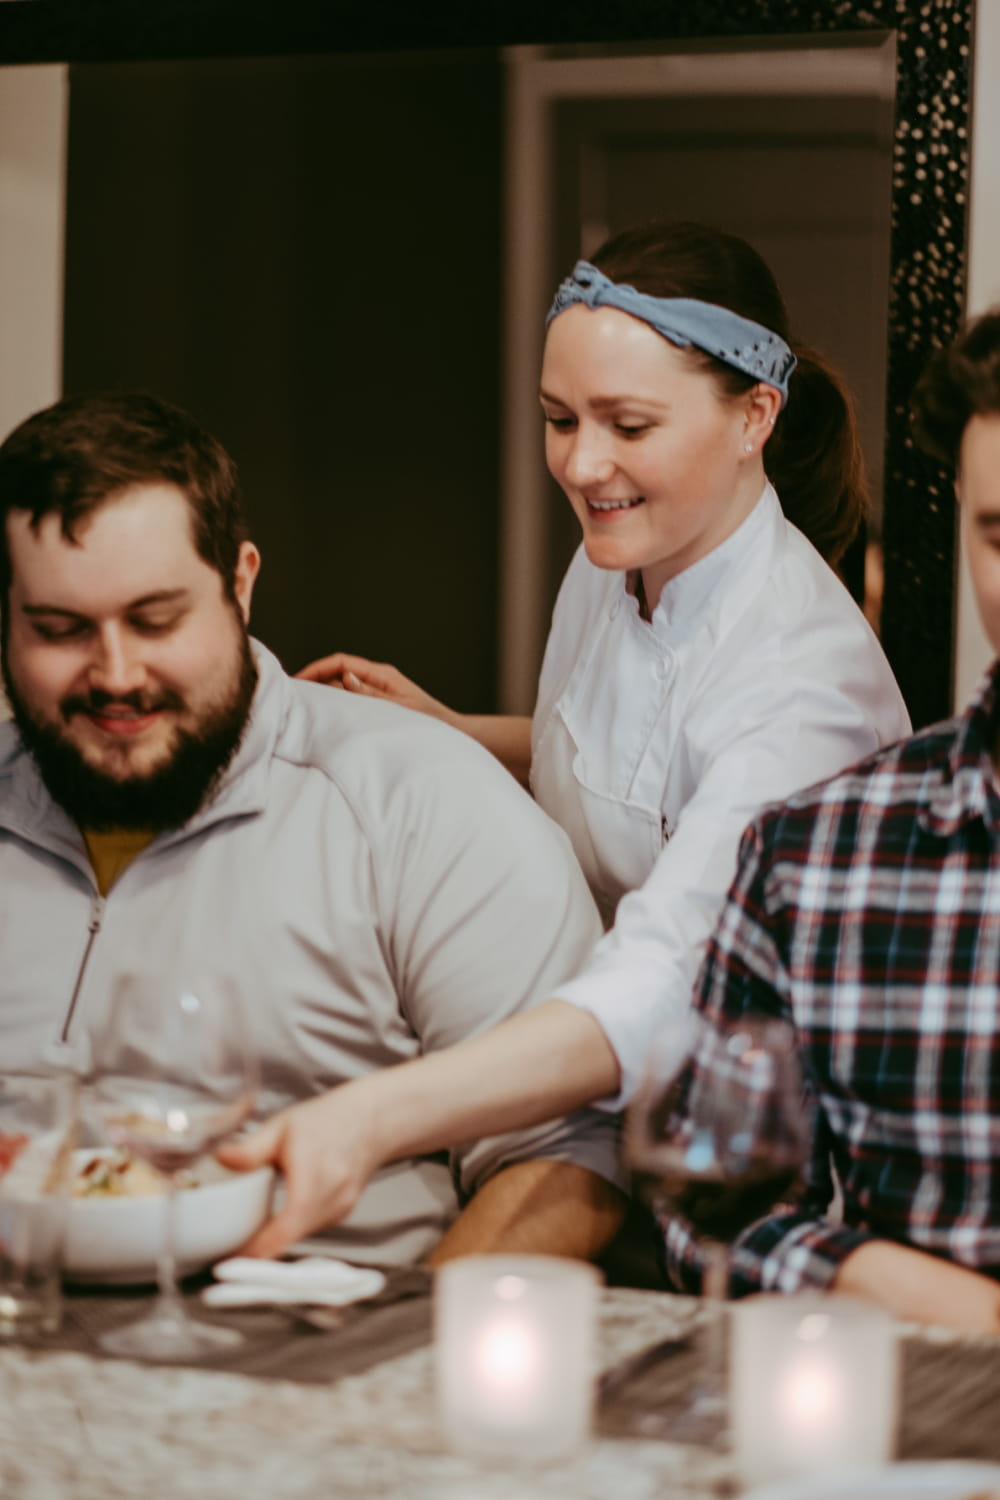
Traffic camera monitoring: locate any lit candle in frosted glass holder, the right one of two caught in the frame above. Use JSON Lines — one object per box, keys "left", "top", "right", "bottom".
{"left": 730, "top": 1293, "right": 898, "bottom": 1485}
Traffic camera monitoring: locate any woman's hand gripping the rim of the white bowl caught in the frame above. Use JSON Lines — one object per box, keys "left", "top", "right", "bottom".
{"left": 216, "top": 1083, "right": 381, "bottom": 1256}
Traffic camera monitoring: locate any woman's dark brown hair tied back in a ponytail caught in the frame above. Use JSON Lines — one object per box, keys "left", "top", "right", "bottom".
{"left": 591, "top": 219, "right": 870, "bottom": 566}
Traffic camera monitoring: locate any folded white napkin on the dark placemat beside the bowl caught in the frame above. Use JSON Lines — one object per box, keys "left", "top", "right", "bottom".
{"left": 201, "top": 1256, "right": 385, "bottom": 1308}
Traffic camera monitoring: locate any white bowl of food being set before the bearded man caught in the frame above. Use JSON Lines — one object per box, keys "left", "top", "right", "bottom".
{"left": 63, "top": 1151, "right": 274, "bottom": 1286}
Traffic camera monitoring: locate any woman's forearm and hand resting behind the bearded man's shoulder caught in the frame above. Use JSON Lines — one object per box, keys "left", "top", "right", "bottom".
{"left": 297, "top": 651, "right": 531, "bottom": 786}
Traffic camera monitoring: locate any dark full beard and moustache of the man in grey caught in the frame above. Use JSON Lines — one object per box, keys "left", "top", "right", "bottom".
{"left": 1, "top": 621, "right": 256, "bottom": 833}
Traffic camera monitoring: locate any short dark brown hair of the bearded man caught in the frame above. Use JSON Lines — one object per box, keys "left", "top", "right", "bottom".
{"left": 0, "top": 390, "right": 246, "bottom": 603}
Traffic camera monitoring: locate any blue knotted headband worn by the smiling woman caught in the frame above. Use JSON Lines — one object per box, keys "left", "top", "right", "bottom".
{"left": 546, "top": 261, "right": 796, "bottom": 407}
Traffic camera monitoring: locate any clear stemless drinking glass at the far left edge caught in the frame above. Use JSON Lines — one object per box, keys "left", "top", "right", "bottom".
{"left": 0, "top": 1073, "right": 78, "bottom": 1338}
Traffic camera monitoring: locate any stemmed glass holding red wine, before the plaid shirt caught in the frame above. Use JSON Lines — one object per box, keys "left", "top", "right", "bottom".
{"left": 625, "top": 1014, "right": 810, "bottom": 1440}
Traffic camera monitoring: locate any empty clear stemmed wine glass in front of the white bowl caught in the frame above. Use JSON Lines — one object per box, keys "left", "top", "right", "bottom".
{"left": 88, "top": 974, "right": 258, "bottom": 1361}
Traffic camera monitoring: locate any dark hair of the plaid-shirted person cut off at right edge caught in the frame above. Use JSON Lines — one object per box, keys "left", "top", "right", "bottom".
{"left": 912, "top": 306, "right": 1000, "bottom": 471}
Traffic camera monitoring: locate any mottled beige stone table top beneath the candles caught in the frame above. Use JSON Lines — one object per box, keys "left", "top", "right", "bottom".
{"left": 0, "top": 1289, "right": 1000, "bottom": 1500}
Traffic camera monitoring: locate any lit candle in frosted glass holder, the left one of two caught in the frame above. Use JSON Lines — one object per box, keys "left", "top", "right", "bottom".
{"left": 435, "top": 1256, "right": 600, "bottom": 1460}
